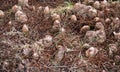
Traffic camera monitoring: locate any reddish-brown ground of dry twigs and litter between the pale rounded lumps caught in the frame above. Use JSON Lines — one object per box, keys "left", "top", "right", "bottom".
{"left": 0, "top": 0, "right": 120, "bottom": 72}
